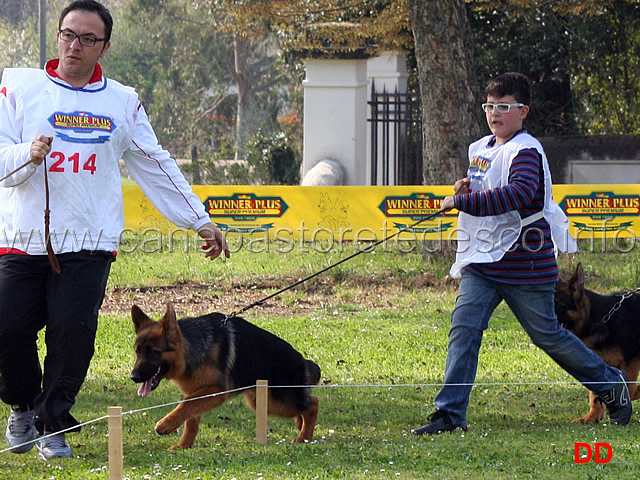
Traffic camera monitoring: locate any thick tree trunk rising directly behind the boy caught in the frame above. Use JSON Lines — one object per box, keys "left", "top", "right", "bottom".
{"left": 407, "top": 0, "right": 483, "bottom": 185}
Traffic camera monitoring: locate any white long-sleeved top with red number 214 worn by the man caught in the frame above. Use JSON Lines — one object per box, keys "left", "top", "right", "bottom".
{"left": 0, "top": 60, "right": 209, "bottom": 255}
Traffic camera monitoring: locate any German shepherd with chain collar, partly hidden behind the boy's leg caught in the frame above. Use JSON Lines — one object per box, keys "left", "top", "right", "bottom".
{"left": 555, "top": 264, "right": 640, "bottom": 423}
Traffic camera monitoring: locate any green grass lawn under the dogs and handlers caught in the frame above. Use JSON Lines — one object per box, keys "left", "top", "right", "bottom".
{"left": 0, "top": 238, "right": 640, "bottom": 480}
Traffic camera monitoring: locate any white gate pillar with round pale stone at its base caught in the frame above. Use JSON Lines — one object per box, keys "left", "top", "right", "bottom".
{"left": 302, "top": 59, "right": 370, "bottom": 185}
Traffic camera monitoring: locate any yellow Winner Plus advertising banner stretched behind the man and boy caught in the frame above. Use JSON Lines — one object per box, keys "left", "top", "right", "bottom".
{"left": 123, "top": 184, "right": 640, "bottom": 243}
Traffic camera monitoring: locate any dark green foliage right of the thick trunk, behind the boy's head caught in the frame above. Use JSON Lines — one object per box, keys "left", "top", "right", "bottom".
{"left": 468, "top": 0, "right": 640, "bottom": 135}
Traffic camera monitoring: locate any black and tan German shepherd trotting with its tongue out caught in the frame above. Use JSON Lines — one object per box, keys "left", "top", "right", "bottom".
{"left": 131, "top": 304, "right": 320, "bottom": 450}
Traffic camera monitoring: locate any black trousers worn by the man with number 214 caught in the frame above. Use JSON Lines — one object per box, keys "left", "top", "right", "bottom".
{"left": 0, "top": 251, "right": 114, "bottom": 431}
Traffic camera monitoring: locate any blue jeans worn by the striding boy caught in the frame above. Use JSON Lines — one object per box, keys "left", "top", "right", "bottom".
{"left": 434, "top": 270, "right": 620, "bottom": 427}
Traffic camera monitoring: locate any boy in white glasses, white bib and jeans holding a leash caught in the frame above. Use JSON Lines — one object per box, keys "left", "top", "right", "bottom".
{"left": 413, "top": 73, "right": 632, "bottom": 435}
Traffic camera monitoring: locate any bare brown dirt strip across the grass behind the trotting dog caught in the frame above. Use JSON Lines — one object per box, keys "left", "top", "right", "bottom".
{"left": 101, "top": 274, "right": 451, "bottom": 317}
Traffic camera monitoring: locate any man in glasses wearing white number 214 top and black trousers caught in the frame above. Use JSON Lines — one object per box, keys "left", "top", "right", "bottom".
{"left": 0, "top": 0, "right": 229, "bottom": 459}
